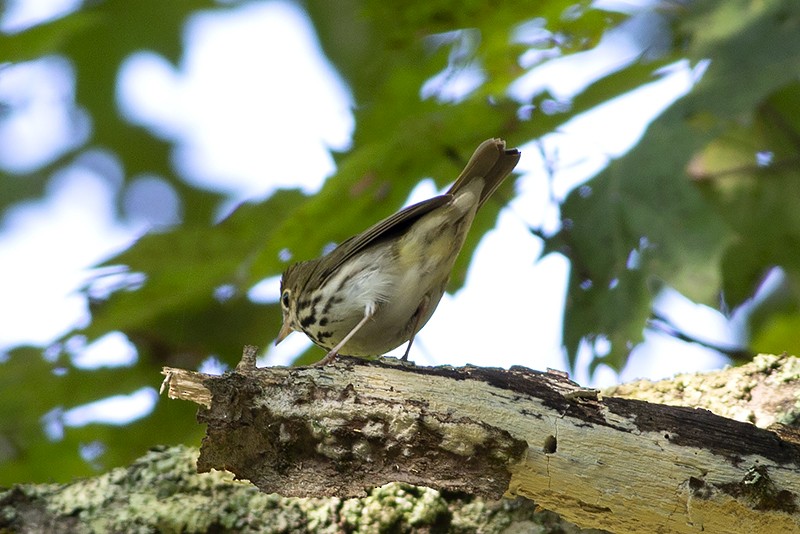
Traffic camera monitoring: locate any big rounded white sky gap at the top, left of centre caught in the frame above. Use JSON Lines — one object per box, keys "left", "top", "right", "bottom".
{"left": 118, "top": 2, "right": 354, "bottom": 199}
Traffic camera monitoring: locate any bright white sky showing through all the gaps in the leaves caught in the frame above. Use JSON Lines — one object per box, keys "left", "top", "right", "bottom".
{"left": 0, "top": 0, "right": 736, "bottom": 432}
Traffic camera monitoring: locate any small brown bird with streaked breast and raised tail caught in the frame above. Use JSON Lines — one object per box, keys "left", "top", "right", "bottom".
{"left": 275, "top": 139, "right": 520, "bottom": 365}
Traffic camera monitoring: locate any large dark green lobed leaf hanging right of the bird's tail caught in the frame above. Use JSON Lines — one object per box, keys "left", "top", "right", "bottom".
{"left": 547, "top": 1, "right": 800, "bottom": 368}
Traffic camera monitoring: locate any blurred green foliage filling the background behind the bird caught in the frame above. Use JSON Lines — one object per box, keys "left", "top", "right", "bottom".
{"left": 0, "top": 0, "right": 800, "bottom": 484}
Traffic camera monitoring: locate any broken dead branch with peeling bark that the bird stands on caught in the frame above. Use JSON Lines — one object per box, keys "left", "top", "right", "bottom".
{"left": 158, "top": 357, "right": 800, "bottom": 532}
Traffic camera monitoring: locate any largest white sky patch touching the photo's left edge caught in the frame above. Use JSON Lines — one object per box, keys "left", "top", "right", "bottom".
{"left": 0, "top": 166, "right": 133, "bottom": 348}
